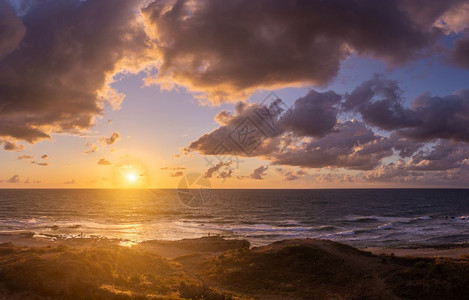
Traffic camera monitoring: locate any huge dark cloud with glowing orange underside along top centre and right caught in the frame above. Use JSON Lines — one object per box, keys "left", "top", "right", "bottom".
{"left": 142, "top": 0, "right": 448, "bottom": 101}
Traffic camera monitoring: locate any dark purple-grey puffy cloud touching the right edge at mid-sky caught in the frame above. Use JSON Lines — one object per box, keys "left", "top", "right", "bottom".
{"left": 343, "top": 75, "right": 469, "bottom": 142}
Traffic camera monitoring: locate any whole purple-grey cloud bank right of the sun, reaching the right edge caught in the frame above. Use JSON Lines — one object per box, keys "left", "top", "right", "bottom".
{"left": 183, "top": 75, "right": 469, "bottom": 177}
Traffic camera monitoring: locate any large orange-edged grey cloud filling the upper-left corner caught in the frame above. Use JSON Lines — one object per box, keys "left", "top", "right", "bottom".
{"left": 0, "top": 0, "right": 146, "bottom": 143}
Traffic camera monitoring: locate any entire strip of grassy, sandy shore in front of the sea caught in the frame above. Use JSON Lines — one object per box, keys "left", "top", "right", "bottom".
{"left": 0, "top": 234, "right": 469, "bottom": 299}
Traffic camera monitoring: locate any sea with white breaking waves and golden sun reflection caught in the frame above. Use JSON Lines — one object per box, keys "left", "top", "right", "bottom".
{"left": 0, "top": 189, "right": 469, "bottom": 248}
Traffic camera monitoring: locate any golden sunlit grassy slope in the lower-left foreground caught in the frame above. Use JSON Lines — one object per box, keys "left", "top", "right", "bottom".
{"left": 0, "top": 244, "right": 239, "bottom": 300}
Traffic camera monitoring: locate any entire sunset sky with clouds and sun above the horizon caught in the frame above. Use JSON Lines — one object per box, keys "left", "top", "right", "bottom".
{"left": 0, "top": 0, "right": 469, "bottom": 189}
